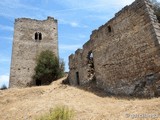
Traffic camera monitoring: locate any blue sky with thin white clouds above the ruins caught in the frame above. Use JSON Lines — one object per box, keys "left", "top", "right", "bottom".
{"left": 0, "top": 0, "right": 154, "bottom": 87}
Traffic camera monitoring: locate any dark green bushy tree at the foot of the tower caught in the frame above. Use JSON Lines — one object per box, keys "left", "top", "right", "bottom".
{"left": 33, "top": 50, "right": 64, "bottom": 85}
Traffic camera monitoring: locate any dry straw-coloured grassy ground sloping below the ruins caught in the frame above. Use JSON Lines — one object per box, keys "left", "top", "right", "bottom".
{"left": 0, "top": 78, "right": 160, "bottom": 120}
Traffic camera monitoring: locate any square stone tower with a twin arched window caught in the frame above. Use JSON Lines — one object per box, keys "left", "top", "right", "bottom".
{"left": 9, "top": 17, "right": 58, "bottom": 88}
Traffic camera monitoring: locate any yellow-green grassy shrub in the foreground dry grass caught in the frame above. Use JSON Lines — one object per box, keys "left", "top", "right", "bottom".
{"left": 37, "top": 106, "right": 74, "bottom": 120}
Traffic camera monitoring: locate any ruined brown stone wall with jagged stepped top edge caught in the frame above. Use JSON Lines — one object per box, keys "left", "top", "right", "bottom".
{"left": 69, "top": 0, "right": 160, "bottom": 97}
